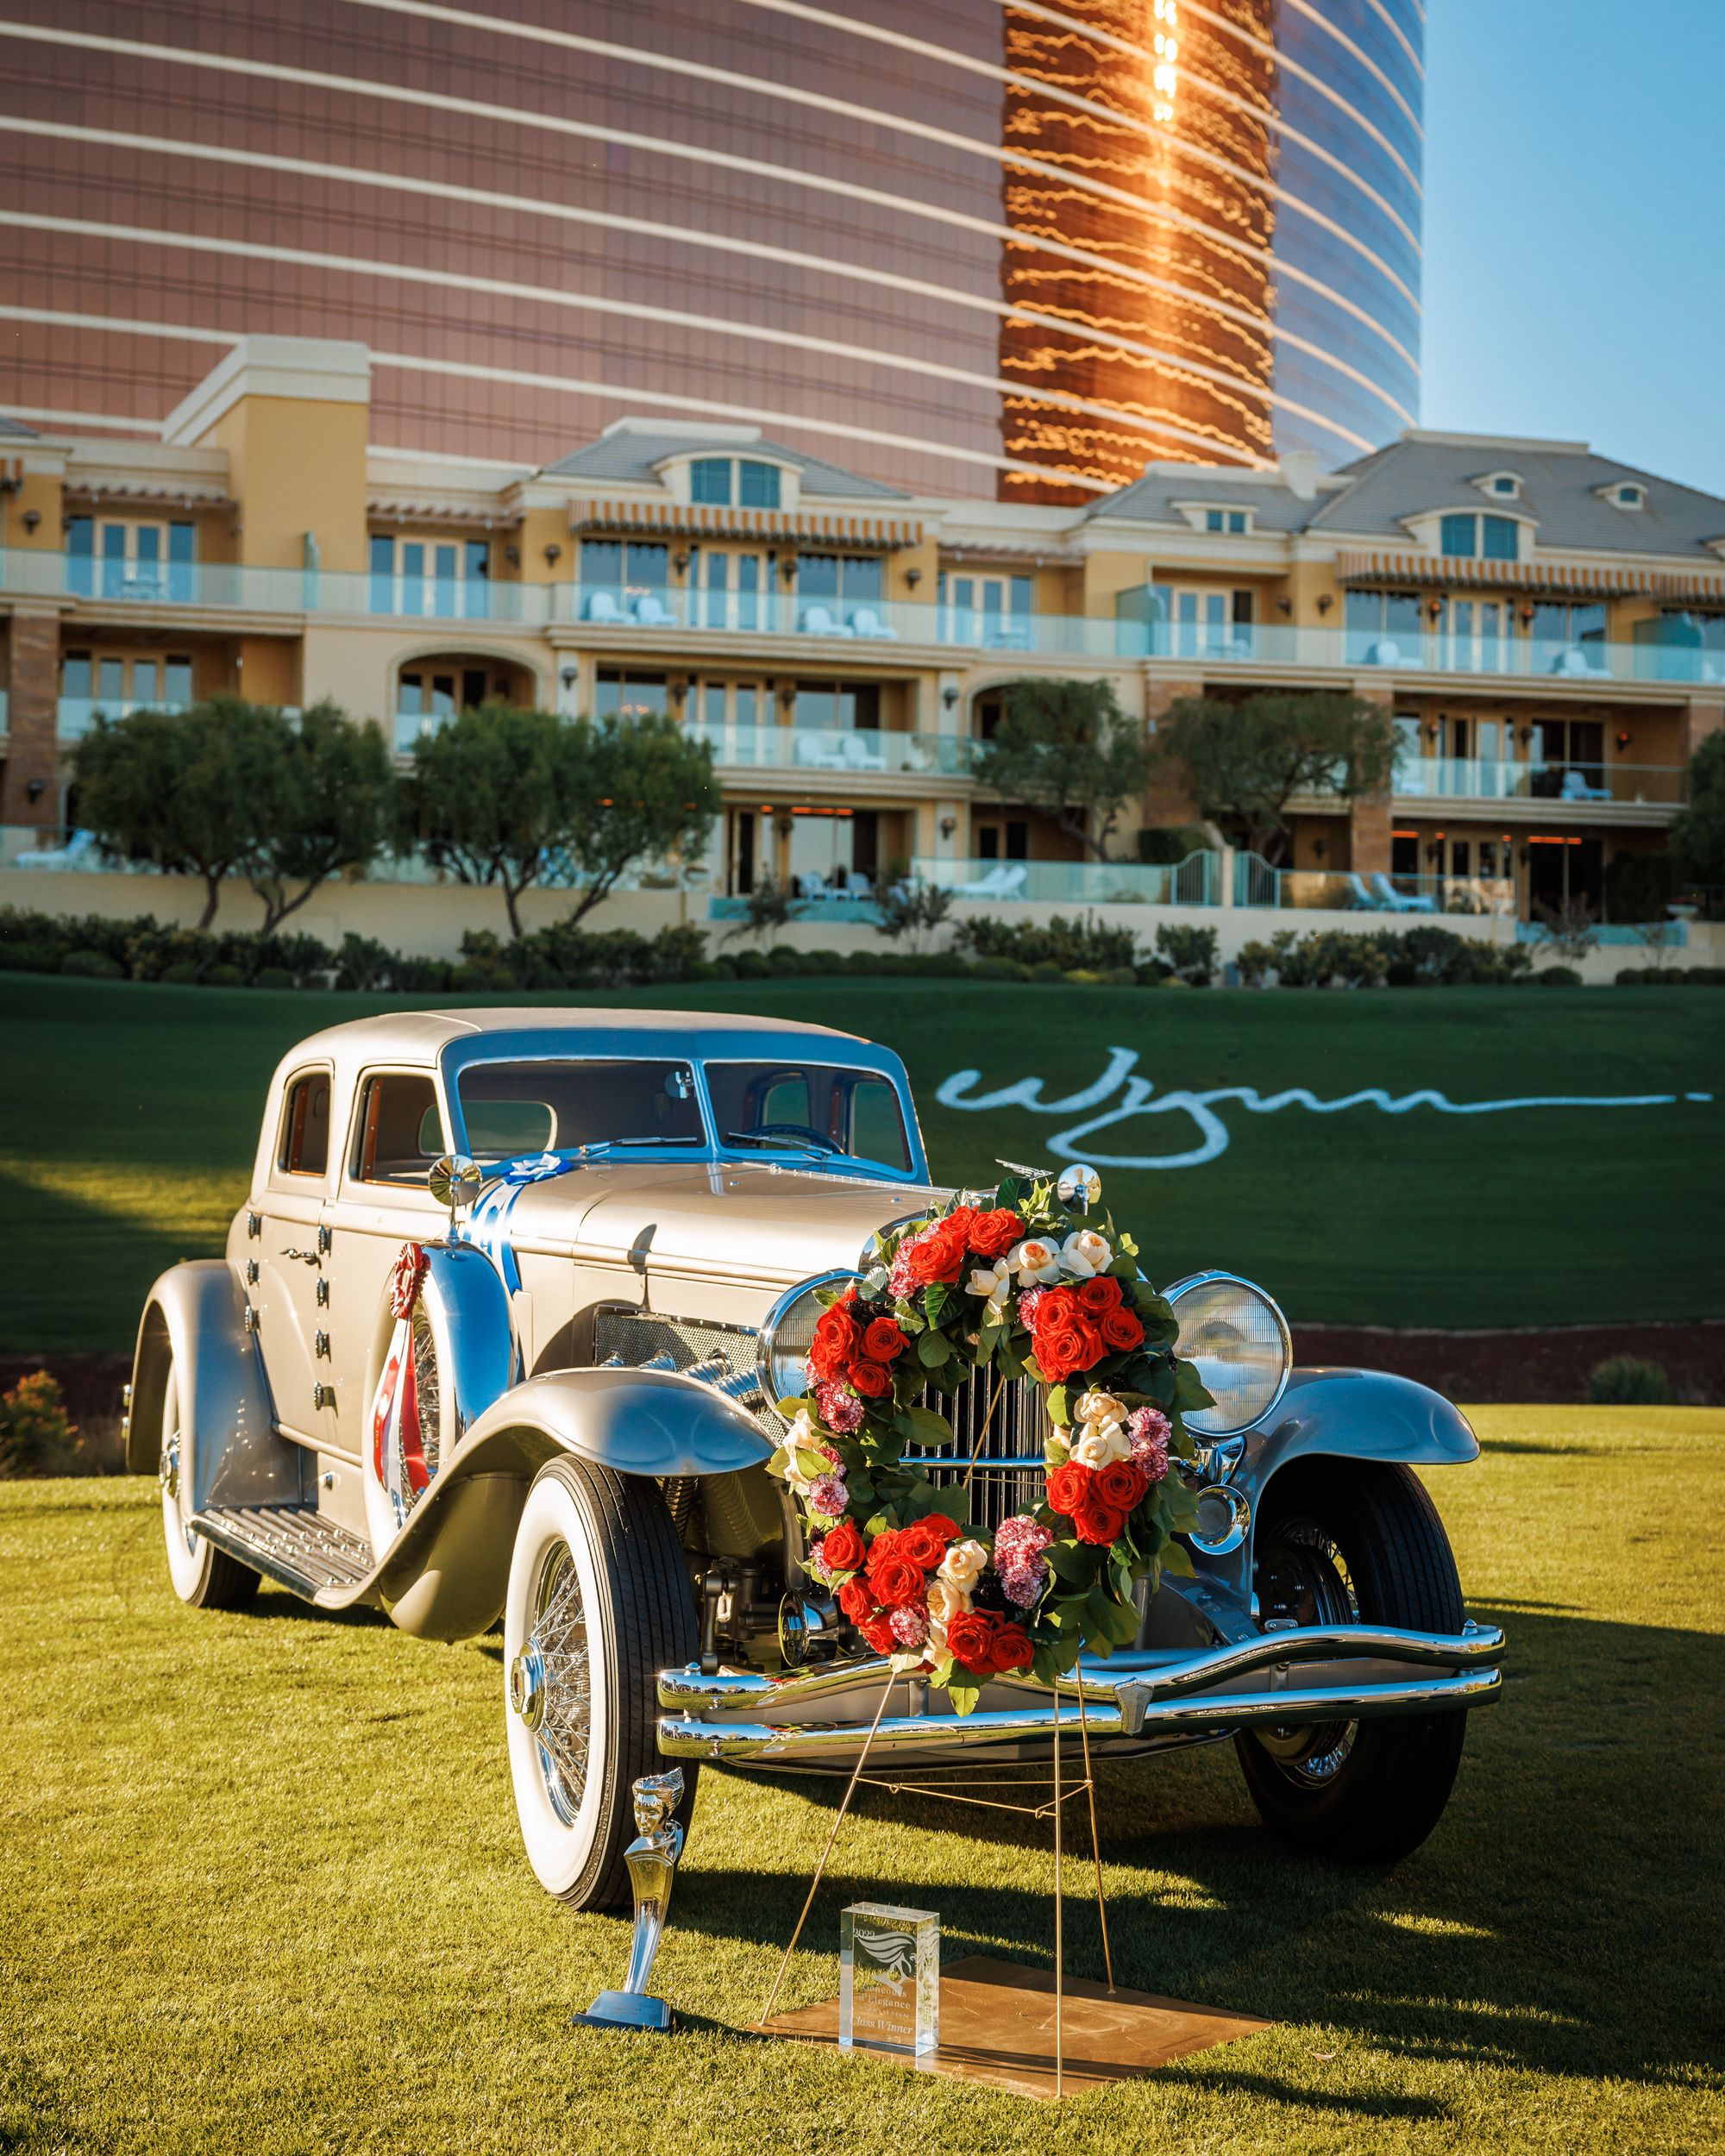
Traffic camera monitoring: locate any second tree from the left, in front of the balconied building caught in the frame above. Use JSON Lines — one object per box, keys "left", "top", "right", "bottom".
{"left": 244, "top": 703, "right": 397, "bottom": 936}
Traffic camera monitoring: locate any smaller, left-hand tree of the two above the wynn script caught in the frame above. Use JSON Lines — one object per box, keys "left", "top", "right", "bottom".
{"left": 970, "top": 681, "right": 1151, "bottom": 861}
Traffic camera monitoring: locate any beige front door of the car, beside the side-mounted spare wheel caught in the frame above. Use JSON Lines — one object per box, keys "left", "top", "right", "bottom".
{"left": 330, "top": 1069, "right": 448, "bottom": 1451}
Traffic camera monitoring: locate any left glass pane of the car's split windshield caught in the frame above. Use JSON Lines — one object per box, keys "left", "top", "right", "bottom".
{"left": 455, "top": 1059, "right": 707, "bottom": 1160}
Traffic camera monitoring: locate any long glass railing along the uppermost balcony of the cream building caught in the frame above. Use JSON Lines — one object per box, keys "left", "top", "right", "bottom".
{"left": 0, "top": 548, "right": 1725, "bottom": 684}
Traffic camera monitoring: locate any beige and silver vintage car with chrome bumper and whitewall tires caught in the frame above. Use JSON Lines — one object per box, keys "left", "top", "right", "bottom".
{"left": 128, "top": 1009, "right": 1503, "bottom": 1906}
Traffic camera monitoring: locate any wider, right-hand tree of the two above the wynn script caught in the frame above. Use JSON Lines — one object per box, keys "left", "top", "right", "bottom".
{"left": 1156, "top": 690, "right": 1396, "bottom": 862}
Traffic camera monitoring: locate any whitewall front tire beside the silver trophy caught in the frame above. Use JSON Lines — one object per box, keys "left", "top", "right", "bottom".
{"left": 503, "top": 1457, "right": 697, "bottom": 1908}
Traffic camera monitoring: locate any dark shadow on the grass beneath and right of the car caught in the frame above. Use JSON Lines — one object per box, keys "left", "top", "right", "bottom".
{"left": 673, "top": 1607, "right": 1725, "bottom": 2087}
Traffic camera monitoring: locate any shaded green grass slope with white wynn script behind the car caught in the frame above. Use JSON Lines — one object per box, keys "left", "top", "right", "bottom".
{"left": 0, "top": 975, "right": 1725, "bottom": 1352}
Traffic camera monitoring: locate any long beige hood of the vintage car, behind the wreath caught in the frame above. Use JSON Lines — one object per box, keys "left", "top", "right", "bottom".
{"left": 498, "top": 1163, "right": 947, "bottom": 1288}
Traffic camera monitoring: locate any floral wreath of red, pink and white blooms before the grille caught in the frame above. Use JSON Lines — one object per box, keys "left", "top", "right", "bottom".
{"left": 768, "top": 1177, "right": 1210, "bottom": 1714}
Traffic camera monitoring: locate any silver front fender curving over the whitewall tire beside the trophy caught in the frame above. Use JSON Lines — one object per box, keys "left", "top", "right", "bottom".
{"left": 375, "top": 1369, "right": 772, "bottom": 1639}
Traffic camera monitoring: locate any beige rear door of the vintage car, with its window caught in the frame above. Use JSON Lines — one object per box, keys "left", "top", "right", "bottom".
{"left": 250, "top": 1063, "right": 338, "bottom": 1456}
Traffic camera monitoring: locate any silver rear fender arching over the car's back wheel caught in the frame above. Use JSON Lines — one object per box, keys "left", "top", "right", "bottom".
{"left": 125, "top": 1257, "right": 310, "bottom": 1512}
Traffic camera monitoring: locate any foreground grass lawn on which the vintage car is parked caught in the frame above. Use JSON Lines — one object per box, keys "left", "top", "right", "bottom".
{"left": 0, "top": 1406, "right": 1725, "bottom": 2156}
